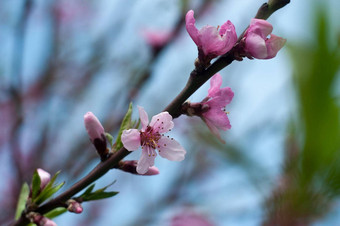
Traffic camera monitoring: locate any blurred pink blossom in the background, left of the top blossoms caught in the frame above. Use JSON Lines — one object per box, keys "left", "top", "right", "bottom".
{"left": 142, "top": 30, "right": 173, "bottom": 48}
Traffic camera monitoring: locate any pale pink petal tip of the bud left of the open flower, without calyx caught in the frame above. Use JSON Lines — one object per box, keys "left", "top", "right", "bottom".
{"left": 84, "top": 112, "right": 105, "bottom": 142}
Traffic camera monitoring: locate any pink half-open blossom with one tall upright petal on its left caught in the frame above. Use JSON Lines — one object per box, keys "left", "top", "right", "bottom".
{"left": 185, "top": 10, "right": 237, "bottom": 61}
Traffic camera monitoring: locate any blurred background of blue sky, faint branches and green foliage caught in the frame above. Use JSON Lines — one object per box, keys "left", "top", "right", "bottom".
{"left": 0, "top": 0, "right": 340, "bottom": 226}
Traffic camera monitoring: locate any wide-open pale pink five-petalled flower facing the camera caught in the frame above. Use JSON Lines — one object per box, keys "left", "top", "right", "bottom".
{"left": 121, "top": 107, "right": 186, "bottom": 174}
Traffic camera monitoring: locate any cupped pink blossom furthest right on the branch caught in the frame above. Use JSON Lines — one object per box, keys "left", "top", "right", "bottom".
{"left": 244, "top": 19, "right": 286, "bottom": 59}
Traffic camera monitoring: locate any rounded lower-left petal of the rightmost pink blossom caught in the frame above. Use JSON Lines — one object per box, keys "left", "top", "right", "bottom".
{"left": 246, "top": 33, "right": 267, "bottom": 59}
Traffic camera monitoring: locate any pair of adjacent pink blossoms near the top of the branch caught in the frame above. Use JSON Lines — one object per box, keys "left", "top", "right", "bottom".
{"left": 185, "top": 10, "right": 286, "bottom": 67}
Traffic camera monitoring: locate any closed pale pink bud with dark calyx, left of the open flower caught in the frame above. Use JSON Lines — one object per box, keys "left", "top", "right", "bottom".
{"left": 84, "top": 112, "right": 108, "bottom": 161}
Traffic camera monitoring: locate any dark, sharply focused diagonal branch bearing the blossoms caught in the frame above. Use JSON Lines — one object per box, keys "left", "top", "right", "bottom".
{"left": 13, "top": 0, "right": 289, "bottom": 226}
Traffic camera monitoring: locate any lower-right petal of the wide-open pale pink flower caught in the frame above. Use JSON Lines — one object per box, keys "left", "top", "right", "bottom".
{"left": 157, "top": 137, "right": 186, "bottom": 161}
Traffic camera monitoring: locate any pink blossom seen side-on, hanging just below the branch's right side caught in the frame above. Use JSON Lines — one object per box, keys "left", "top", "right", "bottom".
{"left": 201, "top": 73, "right": 234, "bottom": 141}
